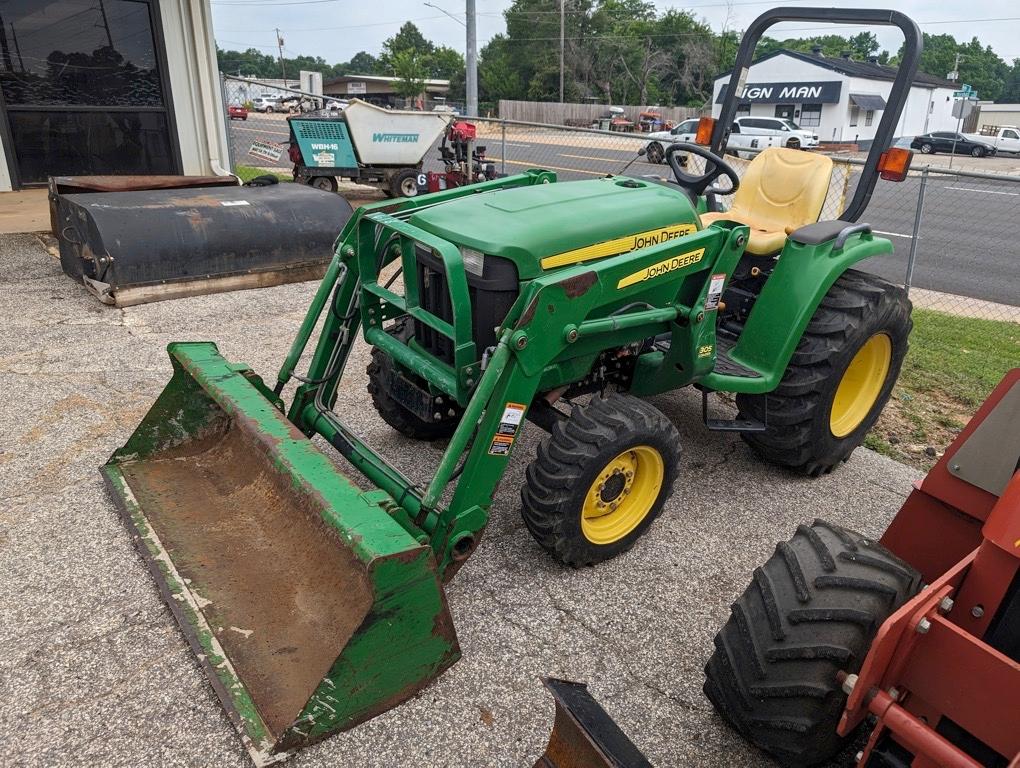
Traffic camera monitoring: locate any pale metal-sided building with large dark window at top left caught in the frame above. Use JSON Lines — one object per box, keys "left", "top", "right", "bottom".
{"left": 0, "top": 0, "right": 230, "bottom": 191}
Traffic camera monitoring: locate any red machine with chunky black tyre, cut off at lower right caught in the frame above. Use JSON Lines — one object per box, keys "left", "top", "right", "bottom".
{"left": 705, "top": 368, "right": 1020, "bottom": 768}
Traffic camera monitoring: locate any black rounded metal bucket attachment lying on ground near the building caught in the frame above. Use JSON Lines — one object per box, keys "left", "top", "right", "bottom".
{"left": 54, "top": 184, "right": 353, "bottom": 307}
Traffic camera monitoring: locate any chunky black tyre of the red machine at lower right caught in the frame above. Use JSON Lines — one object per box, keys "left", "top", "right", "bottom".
{"left": 704, "top": 520, "right": 921, "bottom": 766}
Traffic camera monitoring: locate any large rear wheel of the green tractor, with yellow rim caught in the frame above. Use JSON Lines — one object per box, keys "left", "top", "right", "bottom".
{"left": 736, "top": 269, "right": 913, "bottom": 476}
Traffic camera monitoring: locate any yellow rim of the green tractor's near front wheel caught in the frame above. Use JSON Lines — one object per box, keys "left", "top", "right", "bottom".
{"left": 580, "top": 446, "right": 665, "bottom": 545}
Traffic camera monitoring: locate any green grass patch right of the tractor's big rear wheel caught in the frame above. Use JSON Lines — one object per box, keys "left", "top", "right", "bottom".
{"left": 900, "top": 309, "right": 1020, "bottom": 406}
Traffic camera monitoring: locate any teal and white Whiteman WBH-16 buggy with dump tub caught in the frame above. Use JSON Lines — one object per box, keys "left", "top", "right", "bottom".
{"left": 287, "top": 99, "right": 452, "bottom": 197}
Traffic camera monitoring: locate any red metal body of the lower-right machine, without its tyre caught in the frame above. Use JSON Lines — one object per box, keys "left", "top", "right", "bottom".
{"left": 838, "top": 368, "right": 1020, "bottom": 768}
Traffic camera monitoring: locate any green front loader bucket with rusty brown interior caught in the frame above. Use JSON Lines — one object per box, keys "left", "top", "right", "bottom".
{"left": 102, "top": 343, "right": 460, "bottom": 765}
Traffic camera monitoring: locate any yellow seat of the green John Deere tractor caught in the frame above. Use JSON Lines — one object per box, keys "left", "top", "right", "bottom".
{"left": 701, "top": 147, "right": 832, "bottom": 256}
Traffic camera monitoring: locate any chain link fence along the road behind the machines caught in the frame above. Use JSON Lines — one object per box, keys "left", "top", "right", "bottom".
{"left": 223, "top": 78, "right": 1020, "bottom": 323}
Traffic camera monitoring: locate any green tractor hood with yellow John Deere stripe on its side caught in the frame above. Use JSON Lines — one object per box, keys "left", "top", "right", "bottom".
{"left": 410, "top": 176, "right": 700, "bottom": 279}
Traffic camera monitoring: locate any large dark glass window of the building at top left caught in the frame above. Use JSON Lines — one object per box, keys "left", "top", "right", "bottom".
{"left": 0, "top": 0, "right": 177, "bottom": 185}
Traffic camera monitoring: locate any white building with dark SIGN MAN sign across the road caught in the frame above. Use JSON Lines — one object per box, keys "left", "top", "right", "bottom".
{"left": 712, "top": 49, "right": 957, "bottom": 147}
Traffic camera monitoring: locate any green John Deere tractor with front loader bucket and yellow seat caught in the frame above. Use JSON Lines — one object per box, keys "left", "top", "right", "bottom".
{"left": 103, "top": 9, "right": 916, "bottom": 763}
